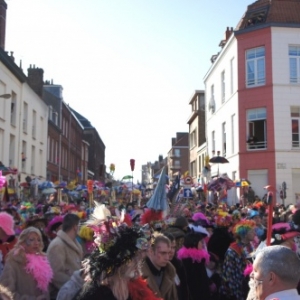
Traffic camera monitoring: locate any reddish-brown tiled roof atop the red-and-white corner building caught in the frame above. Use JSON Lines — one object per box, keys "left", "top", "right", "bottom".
{"left": 236, "top": 0, "right": 300, "bottom": 30}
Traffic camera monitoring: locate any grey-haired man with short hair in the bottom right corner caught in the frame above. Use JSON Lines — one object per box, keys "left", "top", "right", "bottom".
{"left": 250, "top": 245, "right": 300, "bottom": 300}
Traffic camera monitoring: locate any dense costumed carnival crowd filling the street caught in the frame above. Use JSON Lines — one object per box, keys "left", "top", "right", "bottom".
{"left": 0, "top": 186, "right": 300, "bottom": 300}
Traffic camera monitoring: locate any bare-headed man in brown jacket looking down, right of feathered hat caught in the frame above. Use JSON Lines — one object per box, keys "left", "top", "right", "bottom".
{"left": 142, "top": 234, "right": 178, "bottom": 300}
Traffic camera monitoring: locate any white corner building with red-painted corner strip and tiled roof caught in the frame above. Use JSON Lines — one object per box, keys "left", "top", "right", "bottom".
{"left": 205, "top": 0, "right": 300, "bottom": 203}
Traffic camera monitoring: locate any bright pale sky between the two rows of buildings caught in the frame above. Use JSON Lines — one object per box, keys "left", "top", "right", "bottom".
{"left": 5, "top": 0, "right": 254, "bottom": 181}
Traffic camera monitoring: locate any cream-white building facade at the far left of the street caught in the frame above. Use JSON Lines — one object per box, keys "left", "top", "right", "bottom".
{"left": 0, "top": 48, "right": 48, "bottom": 190}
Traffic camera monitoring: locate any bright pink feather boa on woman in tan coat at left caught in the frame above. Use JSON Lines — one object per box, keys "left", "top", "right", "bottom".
{"left": 25, "top": 254, "right": 53, "bottom": 291}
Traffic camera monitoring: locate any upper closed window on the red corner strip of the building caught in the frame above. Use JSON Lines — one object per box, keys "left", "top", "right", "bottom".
{"left": 246, "top": 47, "right": 266, "bottom": 87}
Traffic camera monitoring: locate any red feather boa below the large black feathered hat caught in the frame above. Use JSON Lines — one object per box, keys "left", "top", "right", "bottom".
{"left": 128, "top": 277, "right": 163, "bottom": 300}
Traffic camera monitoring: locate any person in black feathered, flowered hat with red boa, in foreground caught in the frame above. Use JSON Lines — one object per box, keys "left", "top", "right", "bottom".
{"left": 76, "top": 203, "right": 158, "bottom": 300}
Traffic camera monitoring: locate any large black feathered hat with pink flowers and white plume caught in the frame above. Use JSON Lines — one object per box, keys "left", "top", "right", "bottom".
{"left": 85, "top": 203, "right": 148, "bottom": 283}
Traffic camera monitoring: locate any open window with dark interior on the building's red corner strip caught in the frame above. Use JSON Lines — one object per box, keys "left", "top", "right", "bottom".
{"left": 247, "top": 108, "right": 267, "bottom": 150}
